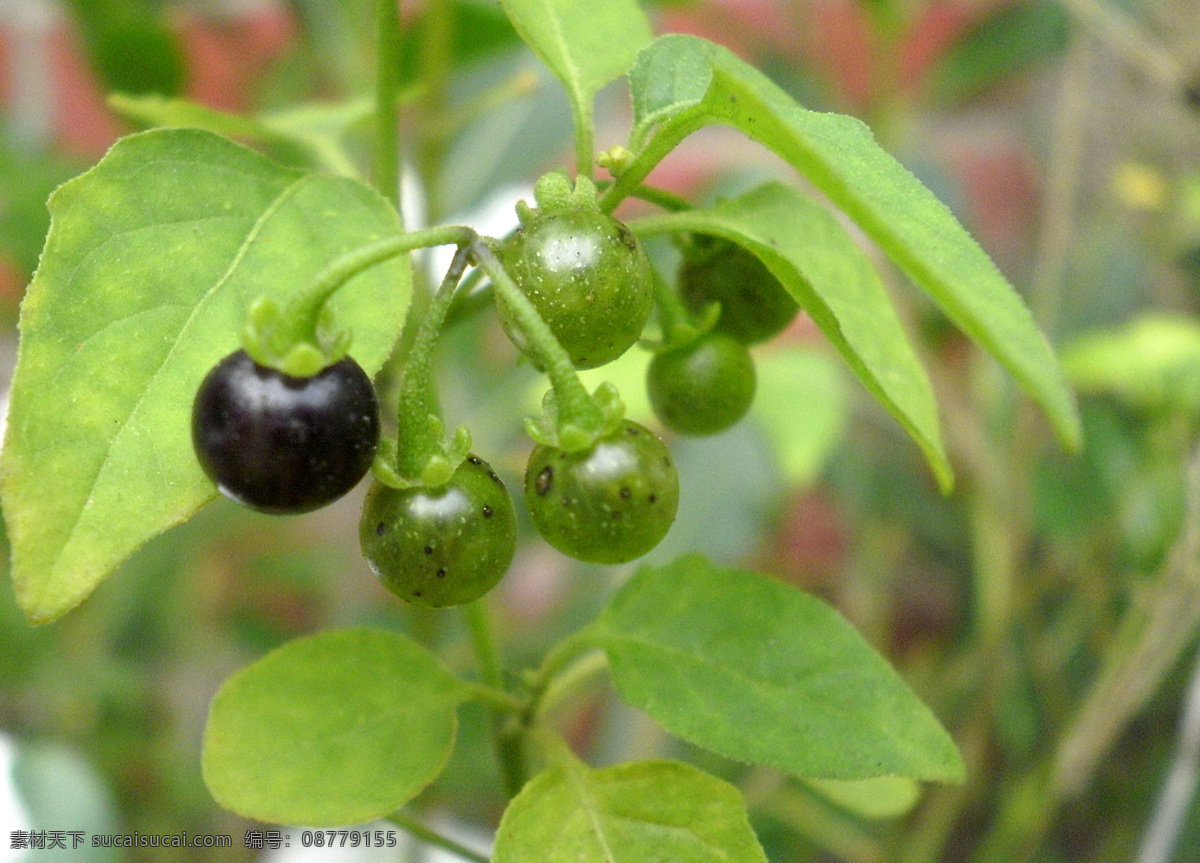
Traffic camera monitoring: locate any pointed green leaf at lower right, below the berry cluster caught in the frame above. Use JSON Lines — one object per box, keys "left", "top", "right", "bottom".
{"left": 593, "top": 556, "right": 964, "bottom": 781}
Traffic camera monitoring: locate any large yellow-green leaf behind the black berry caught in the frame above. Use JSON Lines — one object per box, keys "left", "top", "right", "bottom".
{"left": 0, "top": 130, "right": 410, "bottom": 623}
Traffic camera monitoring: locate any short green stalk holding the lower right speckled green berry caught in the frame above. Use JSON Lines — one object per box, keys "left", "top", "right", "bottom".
{"left": 472, "top": 241, "right": 605, "bottom": 431}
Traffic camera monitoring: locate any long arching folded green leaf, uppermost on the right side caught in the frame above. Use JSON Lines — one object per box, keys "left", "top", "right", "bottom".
{"left": 619, "top": 35, "right": 1081, "bottom": 448}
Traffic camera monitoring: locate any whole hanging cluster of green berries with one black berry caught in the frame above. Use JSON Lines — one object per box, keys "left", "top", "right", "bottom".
{"left": 192, "top": 174, "right": 797, "bottom": 607}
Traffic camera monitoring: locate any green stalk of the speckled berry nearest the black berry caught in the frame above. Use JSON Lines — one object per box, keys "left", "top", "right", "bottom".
{"left": 396, "top": 245, "right": 470, "bottom": 480}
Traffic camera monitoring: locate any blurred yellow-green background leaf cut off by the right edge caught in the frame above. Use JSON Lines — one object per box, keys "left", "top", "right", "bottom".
{"left": 1062, "top": 313, "right": 1200, "bottom": 413}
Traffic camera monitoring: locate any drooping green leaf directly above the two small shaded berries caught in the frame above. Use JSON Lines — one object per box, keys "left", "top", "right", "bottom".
{"left": 630, "top": 182, "right": 954, "bottom": 490}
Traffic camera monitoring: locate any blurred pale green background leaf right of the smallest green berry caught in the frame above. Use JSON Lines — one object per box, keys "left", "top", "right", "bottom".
{"left": 751, "top": 346, "right": 847, "bottom": 486}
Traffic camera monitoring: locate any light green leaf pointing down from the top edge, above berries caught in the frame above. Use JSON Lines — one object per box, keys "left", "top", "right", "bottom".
{"left": 500, "top": 0, "right": 653, "bottom": 170}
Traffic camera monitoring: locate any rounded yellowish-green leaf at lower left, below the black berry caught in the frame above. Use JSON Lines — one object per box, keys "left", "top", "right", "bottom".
{"left": 202, "top": 629, "right": 472, "bottom": 827}
